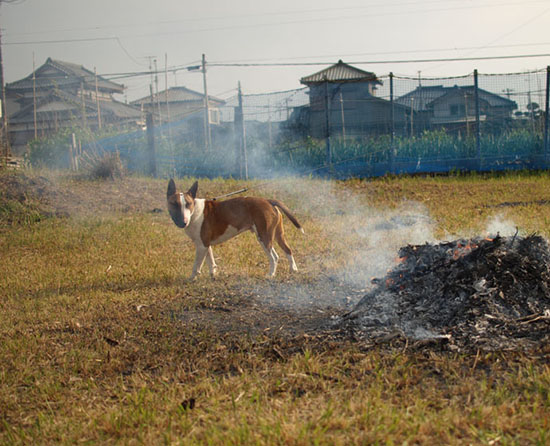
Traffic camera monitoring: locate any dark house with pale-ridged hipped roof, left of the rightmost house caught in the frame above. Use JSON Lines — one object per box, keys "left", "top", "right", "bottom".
{"left": 287, "top": 60, "right": 407, "bottom": 138}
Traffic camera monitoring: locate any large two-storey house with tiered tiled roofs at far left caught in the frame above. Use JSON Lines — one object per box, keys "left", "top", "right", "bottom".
{"left": 6, "top": 58, "right": 141, "bottom": 153}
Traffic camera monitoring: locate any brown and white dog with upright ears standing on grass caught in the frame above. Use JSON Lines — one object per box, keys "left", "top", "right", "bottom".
{"left": 167, "top": 179, "right": 304, "bottom": 279}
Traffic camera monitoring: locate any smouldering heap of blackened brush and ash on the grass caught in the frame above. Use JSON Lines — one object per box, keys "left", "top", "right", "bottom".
{"left": 338, "top": 235, "right": 550, "bottom": 350}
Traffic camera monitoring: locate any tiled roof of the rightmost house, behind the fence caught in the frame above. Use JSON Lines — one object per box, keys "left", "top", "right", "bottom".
{"left": 395, "top": 85, "right": 517, "bottom": 111}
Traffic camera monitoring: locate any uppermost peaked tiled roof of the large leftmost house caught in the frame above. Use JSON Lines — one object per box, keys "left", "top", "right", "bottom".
{"left": 6, "top": 57, "right": 124, "bottom": 93}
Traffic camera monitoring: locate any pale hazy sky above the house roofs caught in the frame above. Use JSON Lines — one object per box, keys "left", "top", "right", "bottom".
{"left": 0, "top": 0, "right": 550, "bottom": 100}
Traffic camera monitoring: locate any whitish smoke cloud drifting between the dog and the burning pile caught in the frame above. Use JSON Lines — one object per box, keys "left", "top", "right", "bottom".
{"left": 251, "top": 178, "right": 440, "bottom": 310}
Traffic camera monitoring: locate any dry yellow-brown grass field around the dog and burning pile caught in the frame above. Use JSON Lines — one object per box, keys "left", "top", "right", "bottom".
{"left": 0, "top": 172, "right": 550, "bottom": 445}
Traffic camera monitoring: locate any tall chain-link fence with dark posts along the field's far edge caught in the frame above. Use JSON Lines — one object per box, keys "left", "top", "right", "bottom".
{"left": 88, "top": 65, "right": 549, "bottom": 178}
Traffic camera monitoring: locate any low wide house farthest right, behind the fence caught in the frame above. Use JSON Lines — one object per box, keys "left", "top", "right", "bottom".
{"left": 396, "top": 85, "right": 517, "bottom": 133}
